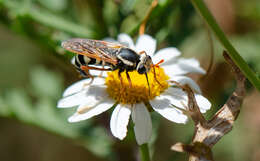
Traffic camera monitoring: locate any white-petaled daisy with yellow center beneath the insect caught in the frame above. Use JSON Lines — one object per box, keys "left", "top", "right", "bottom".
{"left": 57, "top": 34, "right": 211, "bottom": 145}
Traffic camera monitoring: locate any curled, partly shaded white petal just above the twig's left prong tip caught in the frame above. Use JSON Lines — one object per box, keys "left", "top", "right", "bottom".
{"left": 171, "top": 76, "right": 201, "bottom": 93}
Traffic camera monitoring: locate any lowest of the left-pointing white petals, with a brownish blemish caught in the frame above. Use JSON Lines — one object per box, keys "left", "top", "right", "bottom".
{"left": 68, "top": 100, "right": 113, "bottom": 122}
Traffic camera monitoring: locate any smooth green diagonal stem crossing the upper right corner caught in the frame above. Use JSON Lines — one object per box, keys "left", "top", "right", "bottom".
{"left": 191, "top": 0, "right": 260, "bottom": 91}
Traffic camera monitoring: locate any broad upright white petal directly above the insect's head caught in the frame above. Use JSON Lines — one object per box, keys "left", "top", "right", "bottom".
{"left": 135, "top": 34, "right": 156, "bottom": 56}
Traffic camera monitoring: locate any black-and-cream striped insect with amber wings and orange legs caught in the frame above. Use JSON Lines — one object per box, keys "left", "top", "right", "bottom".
{"left": 62, "top": 38, "right": 159, "bottom": 89}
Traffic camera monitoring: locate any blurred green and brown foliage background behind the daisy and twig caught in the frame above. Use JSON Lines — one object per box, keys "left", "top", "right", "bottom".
{"left": 0, "top": 0, "right": 260, "bottom": 161}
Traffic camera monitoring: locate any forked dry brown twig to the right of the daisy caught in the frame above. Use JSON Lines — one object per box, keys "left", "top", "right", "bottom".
{"left": 171, "top": 51, "right": 246, "bottom": 161}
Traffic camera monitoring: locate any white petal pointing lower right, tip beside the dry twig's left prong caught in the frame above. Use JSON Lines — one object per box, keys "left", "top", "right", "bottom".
{"left": 150, "top": 97, "right": 188, "bottom": 123}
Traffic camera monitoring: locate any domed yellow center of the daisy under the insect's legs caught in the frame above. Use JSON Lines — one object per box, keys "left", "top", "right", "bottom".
{"left": 106, "top": 66, "right": 169, "bottom": 105}
